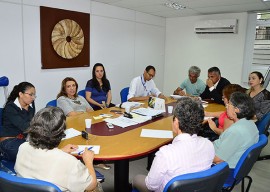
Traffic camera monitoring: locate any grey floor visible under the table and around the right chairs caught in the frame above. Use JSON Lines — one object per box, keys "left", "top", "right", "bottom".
{"left": 98, "top": 138, "right": 270, "bottom": 192}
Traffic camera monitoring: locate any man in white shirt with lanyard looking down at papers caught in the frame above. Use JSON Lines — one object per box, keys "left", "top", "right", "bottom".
{"left": 127, "top": 65, "right": 166, "bottom": 101}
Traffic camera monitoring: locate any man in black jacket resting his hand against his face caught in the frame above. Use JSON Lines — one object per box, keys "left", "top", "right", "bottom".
{"left": 200, "top": 67, "right": 230, "bottom": 104}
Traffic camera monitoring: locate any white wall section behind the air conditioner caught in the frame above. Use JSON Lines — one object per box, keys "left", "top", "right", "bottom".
{"left": 164, "top": 13, "right": 247, "bottom": 94}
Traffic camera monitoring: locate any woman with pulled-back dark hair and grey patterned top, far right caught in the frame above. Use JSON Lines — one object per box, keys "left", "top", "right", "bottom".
{"left": 247, "top": 71, "right": 270, "bottom": 120}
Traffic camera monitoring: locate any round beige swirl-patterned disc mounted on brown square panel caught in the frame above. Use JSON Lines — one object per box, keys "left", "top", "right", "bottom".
{"left": 51, "top": 19, "right": 84, "bottom": 59}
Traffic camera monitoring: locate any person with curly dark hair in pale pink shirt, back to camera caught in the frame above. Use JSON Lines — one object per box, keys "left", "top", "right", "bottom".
{"left": 133, "top": 97, "right": 215, "bottom": 192}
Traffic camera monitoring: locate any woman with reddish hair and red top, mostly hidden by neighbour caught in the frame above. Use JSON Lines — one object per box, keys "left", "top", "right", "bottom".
{"left": 205, "top": 84, "right": 246, "bottom": 135}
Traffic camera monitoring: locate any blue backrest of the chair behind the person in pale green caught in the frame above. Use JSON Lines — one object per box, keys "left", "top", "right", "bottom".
{"left": 233, "top": 134, "right": 268, "bottom": 183}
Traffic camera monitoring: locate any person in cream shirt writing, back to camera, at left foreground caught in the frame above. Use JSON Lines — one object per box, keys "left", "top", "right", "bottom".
{"left": 15, "top": 107, "right": 97, "bottom": 191}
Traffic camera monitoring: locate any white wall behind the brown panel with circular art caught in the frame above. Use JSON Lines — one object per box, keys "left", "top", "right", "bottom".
{"left": 0, "top": 0, "right": 165, "bottom": 109}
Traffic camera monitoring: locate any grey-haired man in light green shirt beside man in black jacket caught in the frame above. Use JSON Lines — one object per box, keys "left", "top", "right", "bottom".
{"left": 173, "top": 66, "right": 205, "bottom": 96}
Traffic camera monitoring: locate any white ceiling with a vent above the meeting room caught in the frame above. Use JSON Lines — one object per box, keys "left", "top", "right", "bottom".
{"left": 92, "top": 0, "right": 270, "bottom": 18}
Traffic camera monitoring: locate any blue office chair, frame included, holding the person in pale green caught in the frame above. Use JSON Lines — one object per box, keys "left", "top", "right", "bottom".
{"left": 223, "top": 134, "right": 268, "bottom": 192}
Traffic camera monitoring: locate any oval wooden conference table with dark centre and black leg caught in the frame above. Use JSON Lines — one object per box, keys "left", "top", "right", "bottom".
{"left": 59, "top": 98, "right": 225, "bottom": 192}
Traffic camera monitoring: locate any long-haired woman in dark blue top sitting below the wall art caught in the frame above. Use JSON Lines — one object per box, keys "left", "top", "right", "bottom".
{"left": 85, "top": 63, "right": 114, "bottom": 110}
